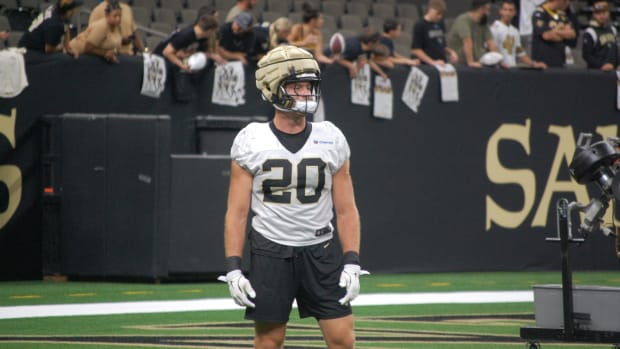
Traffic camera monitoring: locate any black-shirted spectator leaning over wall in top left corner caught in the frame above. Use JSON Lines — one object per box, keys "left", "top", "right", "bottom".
{"left": 17, "top": 0, "right": 82, "bottom": 54}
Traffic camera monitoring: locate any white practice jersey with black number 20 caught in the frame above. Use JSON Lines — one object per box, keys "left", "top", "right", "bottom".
{"left": 230, "top": 121, "right": 350, "bottom": 246}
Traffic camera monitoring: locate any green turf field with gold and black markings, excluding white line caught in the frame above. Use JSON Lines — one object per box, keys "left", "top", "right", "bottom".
{"left": 0, "top": 272, "right": 620, "bottom": 349}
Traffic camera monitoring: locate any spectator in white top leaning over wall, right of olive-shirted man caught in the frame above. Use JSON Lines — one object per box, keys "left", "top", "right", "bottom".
{"left": 491, "top": 0, "right": 547, "bottom": 69}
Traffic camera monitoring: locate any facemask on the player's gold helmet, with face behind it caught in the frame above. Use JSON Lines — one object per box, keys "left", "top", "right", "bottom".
{"left": 273, "top": 73, "right": 321, "bottom": 114}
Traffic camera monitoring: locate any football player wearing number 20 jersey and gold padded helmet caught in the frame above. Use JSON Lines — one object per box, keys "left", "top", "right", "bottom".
{"left": 220, "top": 45, "right": 366, "bottom": 349}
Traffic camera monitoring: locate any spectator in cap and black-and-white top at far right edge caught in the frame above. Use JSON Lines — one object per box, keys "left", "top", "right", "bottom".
{"left": 582, "top": 1, "right": 620, "bottom": 71}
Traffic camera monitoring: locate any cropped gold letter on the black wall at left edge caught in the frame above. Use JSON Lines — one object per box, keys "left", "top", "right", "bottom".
{"left": 0, "top": 108, "right": 22, "bottom": 229}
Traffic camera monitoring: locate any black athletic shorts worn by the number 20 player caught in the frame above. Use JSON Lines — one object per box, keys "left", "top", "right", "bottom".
{"left": 245, "top": 231, "right": 351, "bottom": 323}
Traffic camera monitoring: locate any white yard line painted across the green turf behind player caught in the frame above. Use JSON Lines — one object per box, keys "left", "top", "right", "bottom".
{"left": 0, "top": 291, "right": 534, "bottom": 319}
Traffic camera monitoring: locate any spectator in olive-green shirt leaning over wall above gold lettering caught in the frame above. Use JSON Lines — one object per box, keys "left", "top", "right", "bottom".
{"left": 448, "top": 0, "right": 498, "bottom": 68}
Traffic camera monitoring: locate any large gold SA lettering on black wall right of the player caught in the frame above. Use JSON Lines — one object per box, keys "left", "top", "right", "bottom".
{"left": 485, "top": 118, "right": 618, "bottom": 231}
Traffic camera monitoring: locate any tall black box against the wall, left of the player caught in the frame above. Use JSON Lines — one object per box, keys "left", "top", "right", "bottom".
{"left": 45, "top": 114, "right": 170, "bottom": 279}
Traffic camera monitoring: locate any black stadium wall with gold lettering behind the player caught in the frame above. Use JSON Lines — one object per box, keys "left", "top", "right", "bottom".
{"left": 0, "top": 52, "right": 620, "bottom": 280}
